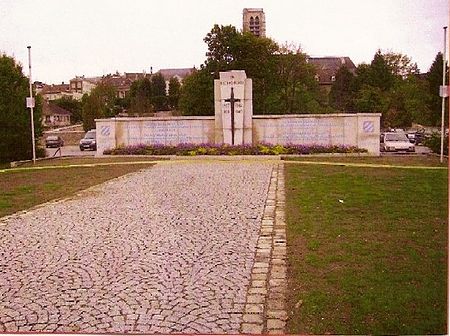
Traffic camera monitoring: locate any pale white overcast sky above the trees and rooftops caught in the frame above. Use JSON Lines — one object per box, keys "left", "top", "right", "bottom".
{"left": 0, "top": 0, "right": 449, "bottom": 84}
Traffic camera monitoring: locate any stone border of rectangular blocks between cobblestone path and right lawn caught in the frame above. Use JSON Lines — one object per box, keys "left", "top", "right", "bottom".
{"left": 240, "top": 163, "right": 288, "bottom": 334}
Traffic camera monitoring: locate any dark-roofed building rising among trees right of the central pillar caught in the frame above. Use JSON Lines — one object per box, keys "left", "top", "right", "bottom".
{"left": 307, "top": 57, "right": 356, "bottom": 92}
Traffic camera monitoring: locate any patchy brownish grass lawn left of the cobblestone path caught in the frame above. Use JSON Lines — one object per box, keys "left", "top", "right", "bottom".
{"left": 0, "top": 158, "right": 156, "bottom": 217}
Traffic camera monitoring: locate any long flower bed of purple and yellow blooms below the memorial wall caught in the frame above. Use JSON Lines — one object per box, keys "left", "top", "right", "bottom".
{"left": 103, "top": 143, "right": 367, "bottom": 156}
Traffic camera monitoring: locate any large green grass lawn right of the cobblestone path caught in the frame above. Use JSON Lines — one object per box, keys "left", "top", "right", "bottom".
{"left": 285, "top": 158, "right": 448, "bottom": 334}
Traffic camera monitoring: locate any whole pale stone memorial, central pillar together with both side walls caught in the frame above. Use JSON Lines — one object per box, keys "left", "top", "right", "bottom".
{"left": 96, "top": 70, "right": 381, "bottom": 155}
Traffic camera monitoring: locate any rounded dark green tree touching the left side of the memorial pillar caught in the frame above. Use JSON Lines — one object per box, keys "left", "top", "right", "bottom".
{"left": 179, "top": 68, "right": 214, "bottom": 116}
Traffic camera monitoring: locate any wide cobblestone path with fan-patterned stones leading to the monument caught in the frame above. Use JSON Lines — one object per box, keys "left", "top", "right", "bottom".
{"left": 0, "top": 162, "right": 274, "bottom": 333}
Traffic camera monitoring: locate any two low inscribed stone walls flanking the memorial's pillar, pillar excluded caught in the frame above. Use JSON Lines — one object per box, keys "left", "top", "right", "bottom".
{"left": 96, "top": 113, "right": 381, "bottom": 155}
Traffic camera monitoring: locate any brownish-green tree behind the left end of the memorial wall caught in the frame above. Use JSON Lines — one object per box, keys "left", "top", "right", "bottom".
{"left": 82, "top": 83, "right": 116, "bottom": 131}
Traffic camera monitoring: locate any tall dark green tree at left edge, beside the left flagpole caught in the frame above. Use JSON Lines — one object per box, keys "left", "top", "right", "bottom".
{"left": 0, "top": 54, "right": 42, "bottom": 162}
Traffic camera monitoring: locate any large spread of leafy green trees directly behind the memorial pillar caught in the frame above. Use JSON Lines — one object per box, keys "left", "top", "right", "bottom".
{"left": 180, "top": 25, "right": 325, "bottom": 115}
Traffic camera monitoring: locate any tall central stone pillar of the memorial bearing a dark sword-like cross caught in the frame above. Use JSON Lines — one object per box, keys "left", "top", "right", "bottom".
{"left": 214, "top": 70, "right": 253, "bottom": 145}
